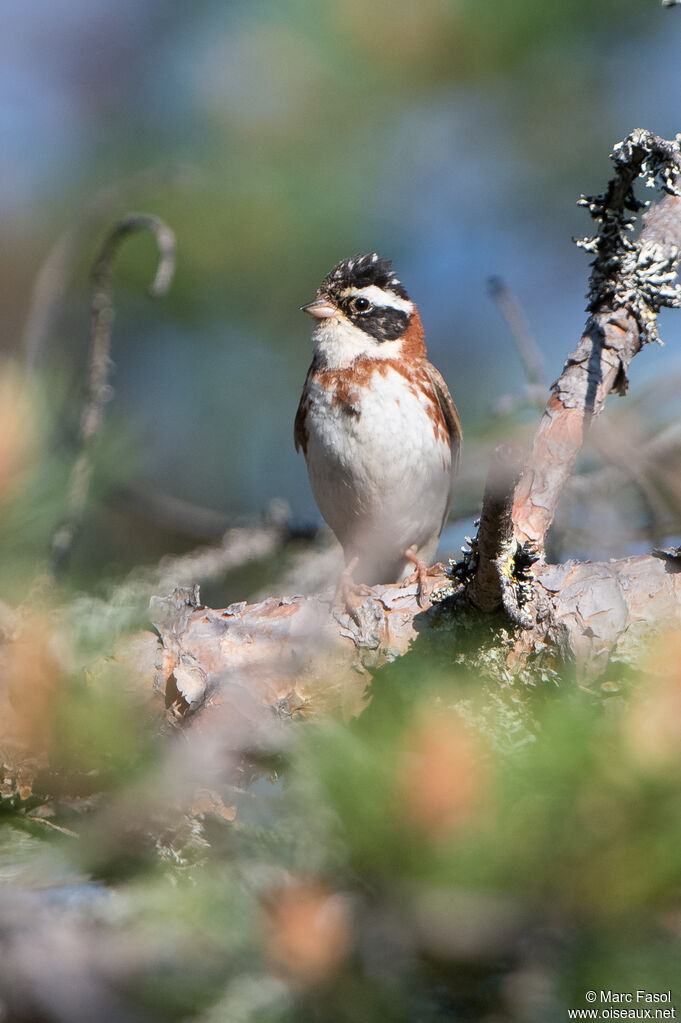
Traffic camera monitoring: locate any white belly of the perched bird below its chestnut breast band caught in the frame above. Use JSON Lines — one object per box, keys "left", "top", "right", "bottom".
{"left": 306, "top": 368, "right": 452, "bottom": 582}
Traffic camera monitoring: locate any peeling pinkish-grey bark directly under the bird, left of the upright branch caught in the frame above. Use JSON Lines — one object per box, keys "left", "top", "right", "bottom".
{"left": 151, "top": 573, "right": 427, "bottom": 731}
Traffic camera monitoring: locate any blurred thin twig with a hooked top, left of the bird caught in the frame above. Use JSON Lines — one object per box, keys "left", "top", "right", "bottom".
{"left": 50, "top": 213, "right": 175, "bottom": 576}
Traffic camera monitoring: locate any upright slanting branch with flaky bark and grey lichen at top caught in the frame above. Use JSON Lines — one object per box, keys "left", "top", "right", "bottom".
{"left": 513, "top": 131, "right": 681, "bottom": 550}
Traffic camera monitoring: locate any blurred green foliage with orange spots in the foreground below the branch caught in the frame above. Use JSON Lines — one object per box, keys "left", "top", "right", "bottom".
{"left": 0, "top": 597, "right": 681, "bottom": 1023}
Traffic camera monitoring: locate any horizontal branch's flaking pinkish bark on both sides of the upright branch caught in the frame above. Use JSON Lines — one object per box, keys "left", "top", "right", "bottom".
{"left": 147, "top": 554, "right": 681, "bottom": 724}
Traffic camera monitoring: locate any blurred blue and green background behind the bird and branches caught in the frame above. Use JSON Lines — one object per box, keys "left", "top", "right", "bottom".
{"left": 0, "top": 0, "right": 681, "bottom": 598}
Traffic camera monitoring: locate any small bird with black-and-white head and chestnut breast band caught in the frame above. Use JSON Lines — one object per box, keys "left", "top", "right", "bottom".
{"left": 293, "top": 253, "right": 461, "bottom": 595}
